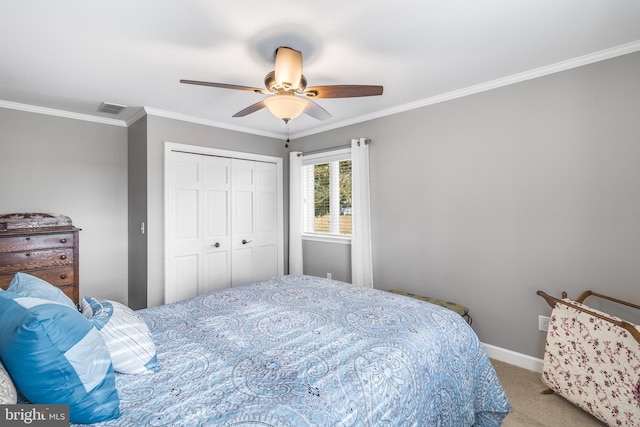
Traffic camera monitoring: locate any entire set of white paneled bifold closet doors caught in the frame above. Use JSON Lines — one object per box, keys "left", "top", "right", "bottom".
{"left": 165, "top": 151, "right": 282, "bottom": 303}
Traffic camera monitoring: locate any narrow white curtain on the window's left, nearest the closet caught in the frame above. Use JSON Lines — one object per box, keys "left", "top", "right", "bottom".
{"left": 289, "top": 151, "right": 302, "bottom": 275}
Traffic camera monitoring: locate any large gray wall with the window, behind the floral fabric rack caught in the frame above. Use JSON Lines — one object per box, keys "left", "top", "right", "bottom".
{"left": 293, "top": 53, "right": 640, "bottom": 357}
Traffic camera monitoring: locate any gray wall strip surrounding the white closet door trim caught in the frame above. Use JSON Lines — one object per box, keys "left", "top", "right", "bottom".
{"left": 146, "top": 116, "right": 289, "bottom": 307}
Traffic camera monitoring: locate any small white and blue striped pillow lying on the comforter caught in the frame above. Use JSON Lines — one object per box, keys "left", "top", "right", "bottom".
{"left": 80, "top": 297, "right": 158, "bottom": 374}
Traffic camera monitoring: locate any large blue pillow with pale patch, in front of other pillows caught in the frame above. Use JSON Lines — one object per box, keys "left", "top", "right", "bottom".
{"left": 0, "top": 291, "right": 120, "bottom": 424}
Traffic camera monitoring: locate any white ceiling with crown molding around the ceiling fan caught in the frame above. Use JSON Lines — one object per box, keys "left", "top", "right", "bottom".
{"left": 0, "top": 0, "right": 640, "bottom": 137}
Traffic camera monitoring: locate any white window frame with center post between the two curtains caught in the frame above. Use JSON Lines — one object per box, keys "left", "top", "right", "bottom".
{"left": 302, "top": 148, "right": 351, "bottom": 245}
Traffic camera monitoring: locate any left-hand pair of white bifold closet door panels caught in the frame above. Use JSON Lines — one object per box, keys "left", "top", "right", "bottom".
{"left": 165, "top": 153, "right": 231, "bottom": 302}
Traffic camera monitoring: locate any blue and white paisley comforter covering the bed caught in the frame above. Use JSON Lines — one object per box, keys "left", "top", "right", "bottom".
{"left": 77, "top": 276, "right": 510, "bottom": 427}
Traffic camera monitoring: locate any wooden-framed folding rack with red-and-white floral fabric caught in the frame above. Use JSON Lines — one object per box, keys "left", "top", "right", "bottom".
{"left": 536, "top": 291, "right": 640, "bottom": 427}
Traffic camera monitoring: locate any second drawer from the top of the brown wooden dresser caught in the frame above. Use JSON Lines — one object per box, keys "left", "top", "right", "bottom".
{"left": 0, "top": 248, "right": 74, "bottom": 274}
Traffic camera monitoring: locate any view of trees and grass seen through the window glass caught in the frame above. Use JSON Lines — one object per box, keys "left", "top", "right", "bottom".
{"left": 311, "top": 160, "right": 352, "bottom": 235}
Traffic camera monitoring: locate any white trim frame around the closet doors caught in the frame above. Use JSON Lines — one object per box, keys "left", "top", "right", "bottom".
{"left": 162, "top": 141, "right": 284, "bottom": 303}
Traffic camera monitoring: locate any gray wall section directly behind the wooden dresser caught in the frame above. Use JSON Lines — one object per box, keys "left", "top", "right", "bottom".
{"left": 0, "top": 108, "right": 127, "bottom": 303}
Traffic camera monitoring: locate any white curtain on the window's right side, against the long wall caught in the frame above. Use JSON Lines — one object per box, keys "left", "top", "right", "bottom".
{"left": 351, "top": 138, "right": 373, "bottom": 288}
